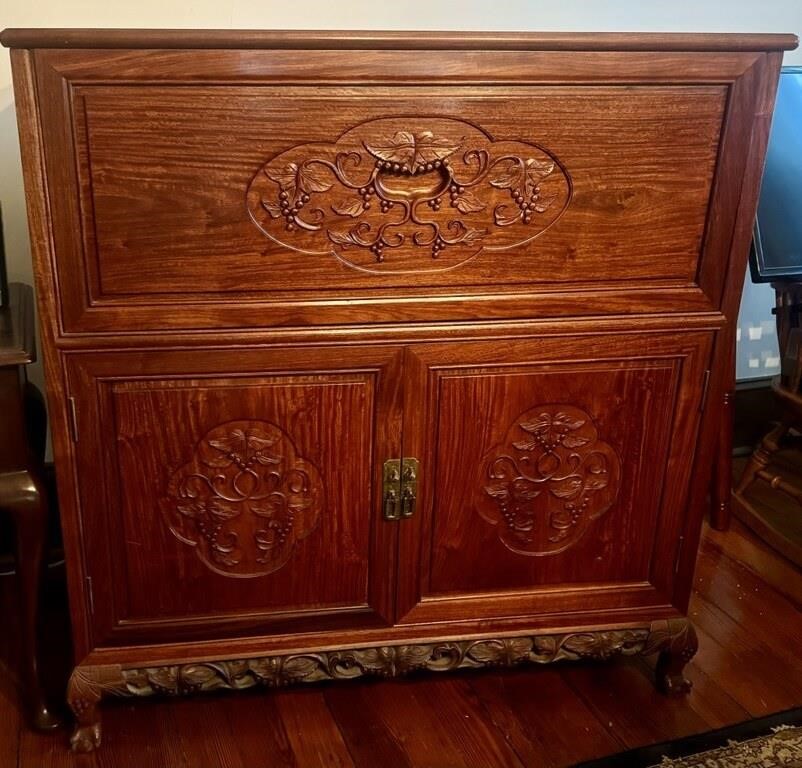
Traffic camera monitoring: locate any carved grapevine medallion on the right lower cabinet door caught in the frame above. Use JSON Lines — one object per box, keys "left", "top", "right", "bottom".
{"left": 476, "top": 405, "right": 621, "bottom": 556}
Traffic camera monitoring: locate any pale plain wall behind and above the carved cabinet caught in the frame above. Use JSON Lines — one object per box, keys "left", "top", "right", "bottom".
{"left": 0, "top": 0, "right": 802, "bottom": 396}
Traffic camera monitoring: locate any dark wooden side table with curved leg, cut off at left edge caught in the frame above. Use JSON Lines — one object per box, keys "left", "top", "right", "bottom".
{"left": 0, "top": 283, "right": 59, "bottom": 730}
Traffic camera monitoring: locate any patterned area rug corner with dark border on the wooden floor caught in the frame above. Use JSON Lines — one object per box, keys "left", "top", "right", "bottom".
{"left": 576, "top": 708, "right": 802, "bottom": 768}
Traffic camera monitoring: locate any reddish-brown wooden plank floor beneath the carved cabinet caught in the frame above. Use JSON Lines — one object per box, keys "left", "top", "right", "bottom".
{"left": 0, "top": 524, "right": 802, "bottom": 768}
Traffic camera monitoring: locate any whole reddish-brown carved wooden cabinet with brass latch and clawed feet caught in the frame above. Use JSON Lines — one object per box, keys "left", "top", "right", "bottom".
{"left": 2, "top": 29, "right": 796, "bottom": 750}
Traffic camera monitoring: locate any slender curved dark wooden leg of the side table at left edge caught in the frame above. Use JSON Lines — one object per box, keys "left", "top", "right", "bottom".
{"left": 0, "top": 471, "right": 61, "bottom": 730}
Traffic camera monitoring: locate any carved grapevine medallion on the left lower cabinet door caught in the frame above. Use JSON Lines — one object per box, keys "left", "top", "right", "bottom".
{"left": 162, "top": 421, "right": 323, "bottom": 577}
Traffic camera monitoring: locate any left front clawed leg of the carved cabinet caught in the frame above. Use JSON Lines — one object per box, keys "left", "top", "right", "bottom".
{"left": 67, "top": 665, "right": 125, "bottom": 752}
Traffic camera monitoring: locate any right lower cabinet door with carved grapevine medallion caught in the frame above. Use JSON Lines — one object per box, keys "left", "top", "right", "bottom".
{"left": 398, "top": 331, "right": 712, "bottom": 622}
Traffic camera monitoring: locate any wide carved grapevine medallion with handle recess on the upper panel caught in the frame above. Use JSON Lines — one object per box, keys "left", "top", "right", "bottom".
{"left": 247, "top": 117, "right": 571, "bottom": 273}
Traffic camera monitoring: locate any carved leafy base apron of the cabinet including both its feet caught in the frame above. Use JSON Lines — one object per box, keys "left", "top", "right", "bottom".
{"left": 67, "top": 617, "right": 697, "bottom": 752}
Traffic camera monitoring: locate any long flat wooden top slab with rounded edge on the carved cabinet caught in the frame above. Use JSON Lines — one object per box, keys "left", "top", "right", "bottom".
{"left": 0, "top": 29, "right": 799, "bottom": 51}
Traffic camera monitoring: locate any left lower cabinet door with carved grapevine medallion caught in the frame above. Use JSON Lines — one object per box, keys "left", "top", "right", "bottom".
{"left": 67, "top": 347, "right": 401, "bottom": 646}
